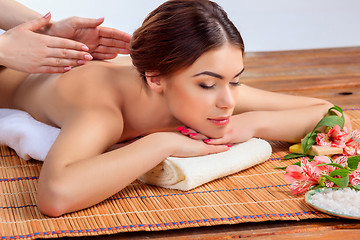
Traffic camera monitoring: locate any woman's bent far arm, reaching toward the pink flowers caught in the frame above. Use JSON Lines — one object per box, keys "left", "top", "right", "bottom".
{"left": 208, "top": 85, "right": 338, "bottom": 144}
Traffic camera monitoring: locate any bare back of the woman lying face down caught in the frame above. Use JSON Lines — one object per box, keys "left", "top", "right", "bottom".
{"left": 0, "top": 57, "right": 167, "bottom": 141}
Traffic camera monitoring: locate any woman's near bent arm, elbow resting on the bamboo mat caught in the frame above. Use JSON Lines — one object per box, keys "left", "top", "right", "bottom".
{"left": 38, "top": 107, "right": 228, "bottom": 216}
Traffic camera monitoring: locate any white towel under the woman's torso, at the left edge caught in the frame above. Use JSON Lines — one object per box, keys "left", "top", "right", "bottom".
{"left": 0, "top": 109, "right": 60, "bottom": 161}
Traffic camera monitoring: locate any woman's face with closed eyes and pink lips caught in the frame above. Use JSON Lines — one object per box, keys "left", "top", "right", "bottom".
{"left": 163, "top": 44, "right": 244, "bottom": 138}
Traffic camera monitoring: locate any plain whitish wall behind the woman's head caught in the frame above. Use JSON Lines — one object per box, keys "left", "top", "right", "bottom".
{"left": 10, "top": 0, "right": 360, "bottom": 51}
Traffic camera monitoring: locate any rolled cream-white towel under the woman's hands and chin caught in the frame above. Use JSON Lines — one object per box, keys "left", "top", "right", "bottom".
{"left": 139, "top": 138, "right": 272, "bottom": 191}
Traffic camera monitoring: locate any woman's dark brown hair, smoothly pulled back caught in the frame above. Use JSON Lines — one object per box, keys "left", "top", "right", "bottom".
{"left": 130, "top": 0, "right": 244, "bottom": 80}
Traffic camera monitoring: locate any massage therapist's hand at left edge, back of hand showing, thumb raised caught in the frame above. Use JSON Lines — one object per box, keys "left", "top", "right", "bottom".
{"left": 0, "top": 14, "right": 92, "bottom": 73}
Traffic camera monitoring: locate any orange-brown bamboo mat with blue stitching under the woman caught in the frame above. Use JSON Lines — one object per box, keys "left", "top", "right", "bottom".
{"left": 0, "top": 109, "right": 360, "bottom": 239}
